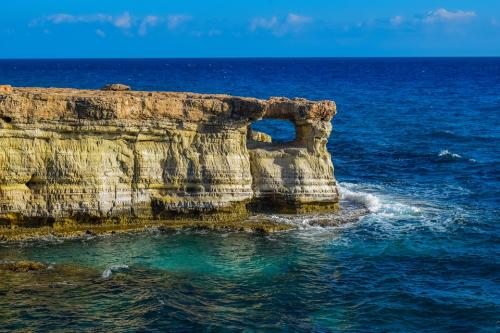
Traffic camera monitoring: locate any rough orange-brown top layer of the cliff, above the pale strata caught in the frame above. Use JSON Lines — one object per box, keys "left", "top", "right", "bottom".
{"left": 0, "top": 85, "right": 336, "bottom": 122}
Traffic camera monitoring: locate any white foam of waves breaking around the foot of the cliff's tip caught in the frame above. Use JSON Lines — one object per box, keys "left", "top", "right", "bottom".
{"left": 250, "top": 183, "right": 453, "bottom": 236}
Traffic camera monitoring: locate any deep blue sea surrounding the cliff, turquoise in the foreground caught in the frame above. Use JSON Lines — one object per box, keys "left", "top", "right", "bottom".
{"left": 0, "top": 58, "right": 500, "bottom": 333}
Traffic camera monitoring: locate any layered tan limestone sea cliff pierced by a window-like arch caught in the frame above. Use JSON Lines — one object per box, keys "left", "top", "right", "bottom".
{"left": 0, "top": 87, "right": 338, "bottom": 224}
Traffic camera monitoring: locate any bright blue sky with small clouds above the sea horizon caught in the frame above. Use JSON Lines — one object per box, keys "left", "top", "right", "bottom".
{"left": 0, "top": 0, "right": 500, "bottom": 58}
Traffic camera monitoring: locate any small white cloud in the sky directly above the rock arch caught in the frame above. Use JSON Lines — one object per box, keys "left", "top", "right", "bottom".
{"left": 250, "top": 13, "right": 312, "bottom": 36}
